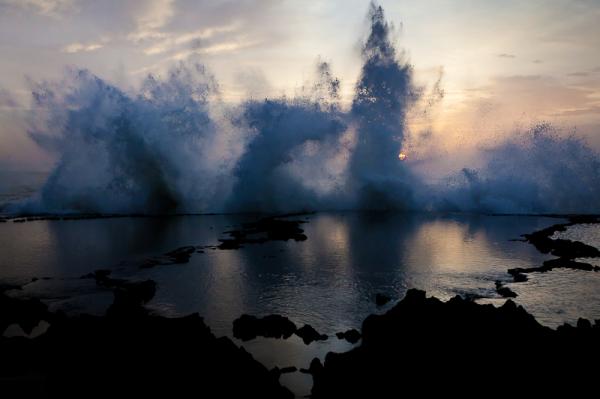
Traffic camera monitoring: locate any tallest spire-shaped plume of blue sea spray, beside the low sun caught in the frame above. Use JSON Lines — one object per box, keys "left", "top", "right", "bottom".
{"left": 349, "top": 3, "right": 420, "bottom": 210}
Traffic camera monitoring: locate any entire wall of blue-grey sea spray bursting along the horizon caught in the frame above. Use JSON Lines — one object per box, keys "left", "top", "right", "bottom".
{"left": 8, "top": 4, "right": 600, "bottom": 217}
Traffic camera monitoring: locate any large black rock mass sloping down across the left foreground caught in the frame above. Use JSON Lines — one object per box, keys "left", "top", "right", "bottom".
{"left": 0, "top": 283, "right": 293, "bottom": 398}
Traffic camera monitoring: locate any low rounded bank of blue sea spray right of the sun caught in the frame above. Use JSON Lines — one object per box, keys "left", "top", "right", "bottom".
{"left": 429, "top": 123, "right": 600, "bottom": 213}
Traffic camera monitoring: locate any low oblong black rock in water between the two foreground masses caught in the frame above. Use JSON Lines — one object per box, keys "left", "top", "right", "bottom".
{"left": 233, "top": 314, "right": 296, "bottom": 341}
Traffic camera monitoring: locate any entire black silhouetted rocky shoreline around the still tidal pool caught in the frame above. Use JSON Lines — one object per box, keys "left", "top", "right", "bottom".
{"left": 0, "top": 212, "right": 600, "bottom": 399}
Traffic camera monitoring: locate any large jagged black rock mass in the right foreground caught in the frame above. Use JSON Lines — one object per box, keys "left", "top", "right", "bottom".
{"left": 311, "top": 290, "right": 600, "bottom": 399}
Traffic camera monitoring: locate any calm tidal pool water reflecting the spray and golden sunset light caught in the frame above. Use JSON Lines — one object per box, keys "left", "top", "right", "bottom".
{"left": 0, "top": 213, "right": 600, "bottom": 391}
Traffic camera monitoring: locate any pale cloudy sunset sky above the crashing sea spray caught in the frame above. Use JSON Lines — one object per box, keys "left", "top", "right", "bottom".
{"left": 0, "top": 0, "right": 600, "bottom": 170}
